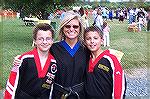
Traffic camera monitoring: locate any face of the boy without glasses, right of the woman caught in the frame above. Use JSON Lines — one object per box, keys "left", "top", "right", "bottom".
{"left": 85, "top": 31, "right": 102, "bottom": 52}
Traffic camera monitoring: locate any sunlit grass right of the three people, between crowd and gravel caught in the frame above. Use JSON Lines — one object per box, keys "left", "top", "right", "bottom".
{"left": 110, "top": 21, "right": 150, "bottom": 69}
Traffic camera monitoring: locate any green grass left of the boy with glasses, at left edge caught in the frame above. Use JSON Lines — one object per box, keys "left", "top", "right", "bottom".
{"left": 1, "top": 19, "right": 32, "bottom": 87}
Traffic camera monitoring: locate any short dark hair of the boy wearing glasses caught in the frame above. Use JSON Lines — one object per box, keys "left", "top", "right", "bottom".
{"left": 33, "top": 23, "right": 54, "bottom": 40}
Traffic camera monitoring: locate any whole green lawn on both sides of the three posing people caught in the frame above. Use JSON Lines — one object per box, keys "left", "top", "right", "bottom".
{"left": 0, "top": 18, "right": 150, "bottom": 88}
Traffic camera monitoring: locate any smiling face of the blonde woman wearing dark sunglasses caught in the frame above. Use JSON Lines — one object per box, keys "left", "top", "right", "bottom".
{"left": 63, "top": 19, "right": 80, "bottom": 39}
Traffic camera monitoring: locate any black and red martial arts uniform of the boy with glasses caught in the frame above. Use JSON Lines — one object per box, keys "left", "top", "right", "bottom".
{"left": 4, "top": 48, "right": 57, "bottom": 99}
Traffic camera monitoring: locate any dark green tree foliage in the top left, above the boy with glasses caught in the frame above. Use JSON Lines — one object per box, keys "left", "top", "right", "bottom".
{"left": 2, "top": 0, "right": 76, "bottom": 19}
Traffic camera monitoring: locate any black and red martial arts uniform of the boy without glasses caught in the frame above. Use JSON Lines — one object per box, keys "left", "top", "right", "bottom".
{"left": 85, "top": 50, "right": 126, "bottom": 99}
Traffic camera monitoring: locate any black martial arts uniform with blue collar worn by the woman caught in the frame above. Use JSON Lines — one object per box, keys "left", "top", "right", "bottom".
{"left": 51, "top": 41, "right": 87, "bottom": 99}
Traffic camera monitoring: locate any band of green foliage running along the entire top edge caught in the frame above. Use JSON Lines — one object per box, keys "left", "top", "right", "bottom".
{"left": 2, "top": 0, "right": 150, "bottom": 19}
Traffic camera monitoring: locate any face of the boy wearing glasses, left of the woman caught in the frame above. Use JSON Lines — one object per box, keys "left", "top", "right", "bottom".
{"left": 34, "top": 30, "right": 53, "bottom": 52}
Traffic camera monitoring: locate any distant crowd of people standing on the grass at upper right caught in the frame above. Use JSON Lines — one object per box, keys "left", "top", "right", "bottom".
{"left": 92, "top": 7, "right": 150, "bottom": 31}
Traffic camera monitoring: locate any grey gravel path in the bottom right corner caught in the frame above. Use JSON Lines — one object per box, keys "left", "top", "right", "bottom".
{"left": 125, "top": 67, "right": 150, "bottom": 99}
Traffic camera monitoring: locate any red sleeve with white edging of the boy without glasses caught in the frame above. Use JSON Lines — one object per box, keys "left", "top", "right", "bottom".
{"left": 110, "top": 55, "right": 126, "bottom": 99}
